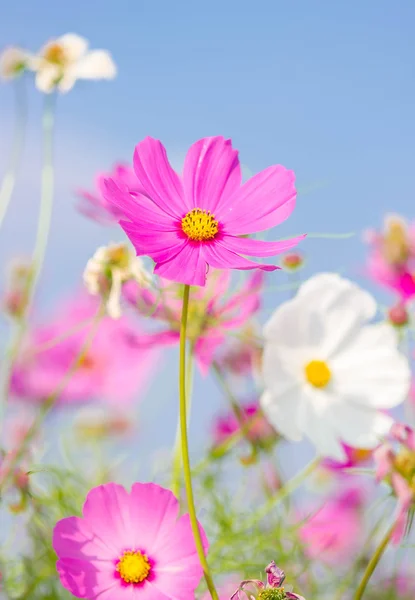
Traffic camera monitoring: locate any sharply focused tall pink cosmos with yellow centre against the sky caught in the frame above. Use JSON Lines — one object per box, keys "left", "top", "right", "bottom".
{"left": 105, "top": 137, "right": 304, "bottom": 286}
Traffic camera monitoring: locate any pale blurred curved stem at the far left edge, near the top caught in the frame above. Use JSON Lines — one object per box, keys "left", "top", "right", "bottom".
{"left": 0, "top": 78, "right": 27, "bottom": 227}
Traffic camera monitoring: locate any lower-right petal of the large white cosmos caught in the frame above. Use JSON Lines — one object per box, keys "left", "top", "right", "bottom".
{"left": 333, "top": 404, "right": 393, "bottom": 448}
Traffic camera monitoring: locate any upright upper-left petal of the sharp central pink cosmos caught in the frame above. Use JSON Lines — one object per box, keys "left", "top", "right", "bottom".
{"left": 134, "top": 137, "right": 186, "bottom": 219}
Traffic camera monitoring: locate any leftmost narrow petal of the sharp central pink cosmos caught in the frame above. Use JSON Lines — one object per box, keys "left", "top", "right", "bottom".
{"left": 103, "top": 179, "right": 177, "bottom": 231}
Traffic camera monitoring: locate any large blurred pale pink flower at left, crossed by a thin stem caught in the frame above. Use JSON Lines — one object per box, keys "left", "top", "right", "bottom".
{"left": 12, "top": 294, "right": 157, "bottom": 403}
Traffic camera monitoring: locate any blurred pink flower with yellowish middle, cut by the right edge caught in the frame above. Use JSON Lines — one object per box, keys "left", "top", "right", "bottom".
{"left": 366, "top": 215, "right": 415, "bottom": 302}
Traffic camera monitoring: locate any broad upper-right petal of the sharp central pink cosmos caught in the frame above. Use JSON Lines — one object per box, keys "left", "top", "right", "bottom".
{"left": 216, "top": 165, "right": 296, "bottom": 235}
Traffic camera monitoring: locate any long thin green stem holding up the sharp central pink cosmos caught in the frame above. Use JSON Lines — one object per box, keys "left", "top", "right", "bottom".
{"left": 179, "top": 285, "right": 219, "bottom": 600}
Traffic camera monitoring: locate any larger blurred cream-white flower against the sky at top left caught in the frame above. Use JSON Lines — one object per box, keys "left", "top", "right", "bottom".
{"left": 29, "top": 33, "right": 117, "bottom": 93}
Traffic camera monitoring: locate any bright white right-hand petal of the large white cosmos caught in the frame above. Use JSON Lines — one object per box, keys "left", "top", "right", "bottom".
{"left": 330, "top": 323, "right": 411, "bottom": 409}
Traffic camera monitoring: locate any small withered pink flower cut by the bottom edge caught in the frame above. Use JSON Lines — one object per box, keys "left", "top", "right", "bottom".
{"left": 230, "top": 561, "right": 305, "bottom": 600}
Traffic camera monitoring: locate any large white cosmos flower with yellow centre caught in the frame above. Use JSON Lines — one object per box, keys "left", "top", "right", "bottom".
{"left": 261, "top": 273, "right": 410, "bottom": 459}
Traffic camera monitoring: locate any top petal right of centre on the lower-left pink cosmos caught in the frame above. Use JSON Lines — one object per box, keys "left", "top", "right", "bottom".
{"left": 130, "top": 483, "right": 179, "bottom": 552}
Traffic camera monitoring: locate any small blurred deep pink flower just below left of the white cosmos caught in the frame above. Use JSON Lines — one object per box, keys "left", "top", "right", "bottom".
{"left": 213, "top": 402, "right": 277, "bottom": 446}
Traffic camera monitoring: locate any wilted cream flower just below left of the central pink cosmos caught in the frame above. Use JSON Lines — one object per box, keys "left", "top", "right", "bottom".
{"left": 84, "top": 244, "right": 151, "bottom": 319}
